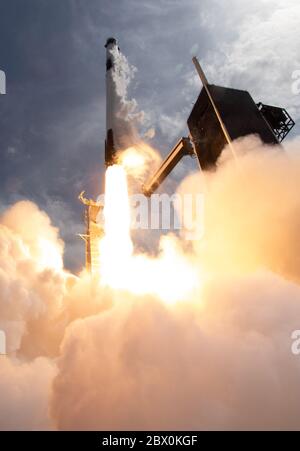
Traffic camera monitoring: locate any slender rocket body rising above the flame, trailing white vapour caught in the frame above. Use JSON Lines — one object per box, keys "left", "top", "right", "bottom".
{"left": 105, "top": 38, "right": 120, "bottom": 167}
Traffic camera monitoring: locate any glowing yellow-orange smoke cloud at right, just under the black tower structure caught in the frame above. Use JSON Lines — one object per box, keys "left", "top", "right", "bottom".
{"left": 181, "top": 137, "right": 300, "bottom": 283}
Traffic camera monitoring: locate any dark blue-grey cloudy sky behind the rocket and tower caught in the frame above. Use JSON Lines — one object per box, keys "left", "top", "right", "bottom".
{"left": 0, "top": 0, "right": 300, "bottom": 269}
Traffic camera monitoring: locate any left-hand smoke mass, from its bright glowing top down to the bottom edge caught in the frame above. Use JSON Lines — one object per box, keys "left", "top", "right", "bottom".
{"left": 0, "top": 201, "right": 111, "bottom": 430}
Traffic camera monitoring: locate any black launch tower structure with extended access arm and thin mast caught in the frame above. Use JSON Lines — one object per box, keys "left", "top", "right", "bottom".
{"left": 143, "top": 57, "right": 295, "bottom": 197}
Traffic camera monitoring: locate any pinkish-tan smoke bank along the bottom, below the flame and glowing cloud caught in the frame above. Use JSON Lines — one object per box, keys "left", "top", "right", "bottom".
{"left": 52, "top": 274, "right": 300, "bottom": 430}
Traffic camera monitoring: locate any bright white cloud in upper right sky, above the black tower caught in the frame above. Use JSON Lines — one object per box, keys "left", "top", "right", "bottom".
{"left": 187, "top": 0, "right": 300, "bottom": 131}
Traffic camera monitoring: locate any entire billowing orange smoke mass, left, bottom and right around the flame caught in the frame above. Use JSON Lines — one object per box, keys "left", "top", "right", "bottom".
{"left": 0, "top": 138, "right": 300, "bottom": 430}
